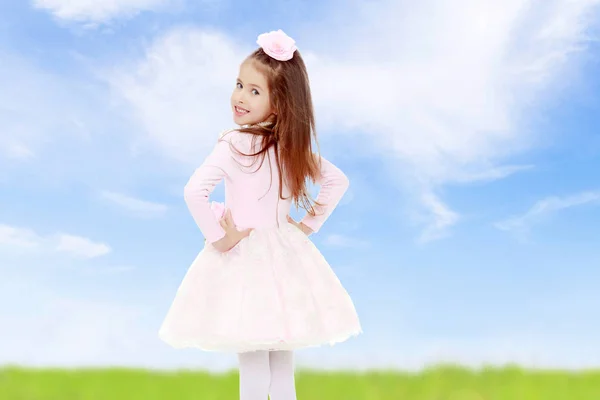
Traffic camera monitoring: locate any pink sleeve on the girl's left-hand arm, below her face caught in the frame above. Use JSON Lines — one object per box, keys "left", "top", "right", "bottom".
{"left": 183, "top": 140, "right": 233, "bottom": 243}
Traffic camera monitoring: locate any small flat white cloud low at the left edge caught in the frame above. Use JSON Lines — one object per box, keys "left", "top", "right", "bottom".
{"left": 0, "top": 224, "right": 111, "bottom": 258}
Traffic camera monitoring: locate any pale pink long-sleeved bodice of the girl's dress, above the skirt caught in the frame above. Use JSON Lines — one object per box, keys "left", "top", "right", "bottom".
{"left": 184, "top": 131, "right": 349, "bottom": 243}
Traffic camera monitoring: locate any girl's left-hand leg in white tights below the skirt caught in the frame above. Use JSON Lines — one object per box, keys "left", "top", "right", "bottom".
{"left": 238, "top": 351, "right": 271, "bottom": 400}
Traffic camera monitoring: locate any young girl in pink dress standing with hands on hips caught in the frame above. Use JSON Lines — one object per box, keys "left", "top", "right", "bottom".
{"left": 159, "top": 30, "right": 361, "bottom": 400}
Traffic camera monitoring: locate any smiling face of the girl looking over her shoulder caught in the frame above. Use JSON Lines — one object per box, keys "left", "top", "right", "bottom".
{"left": 231, "top": 61, "right": 274, "bottom": 125}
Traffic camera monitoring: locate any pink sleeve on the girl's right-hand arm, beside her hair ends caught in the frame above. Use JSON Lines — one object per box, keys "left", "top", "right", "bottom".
{"left": 302, "top": 157, "right": 350, "bottom": 232}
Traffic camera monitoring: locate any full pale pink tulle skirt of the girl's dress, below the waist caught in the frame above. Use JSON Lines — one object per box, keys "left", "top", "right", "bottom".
{"left": 159, "top": 223, "right": 362, "bottom": 352}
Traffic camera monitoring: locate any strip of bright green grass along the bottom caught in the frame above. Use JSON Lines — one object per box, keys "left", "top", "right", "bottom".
{"left": 0, "top": 366, "right": 600, "bottom": 400}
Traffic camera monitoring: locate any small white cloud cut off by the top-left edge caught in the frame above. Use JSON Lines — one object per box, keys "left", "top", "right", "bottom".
{"left": 33, "top": 0, "right": 180, "bottom": 26}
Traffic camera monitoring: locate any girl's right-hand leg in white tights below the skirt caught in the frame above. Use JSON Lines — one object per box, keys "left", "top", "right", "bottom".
{"left": 269, "top": 351, "right": 296, "bottom": 400}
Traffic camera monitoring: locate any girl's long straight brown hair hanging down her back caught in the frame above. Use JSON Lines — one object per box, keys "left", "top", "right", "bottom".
{"left": 230, "top": 48, "right": 321, "bottom": 215}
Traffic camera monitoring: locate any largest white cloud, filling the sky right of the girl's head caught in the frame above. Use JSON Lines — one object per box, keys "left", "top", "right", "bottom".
{"left": 308, "top": 0, "right": 598, "bottom": 237}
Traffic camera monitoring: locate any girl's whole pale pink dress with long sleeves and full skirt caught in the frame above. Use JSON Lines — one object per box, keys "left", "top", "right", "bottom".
{"left": 159, "top": 131, "right": 361, "bottom": 352}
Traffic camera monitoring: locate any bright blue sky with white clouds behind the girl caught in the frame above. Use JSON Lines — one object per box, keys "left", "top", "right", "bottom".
{"left": 0, "top": 0, "right": 600, "bottom": 370}
